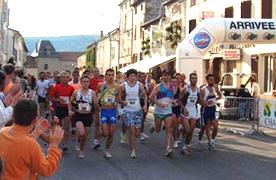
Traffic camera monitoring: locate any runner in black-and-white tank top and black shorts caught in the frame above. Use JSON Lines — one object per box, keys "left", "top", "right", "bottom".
{"left": 71, "top": 76, "right": 97, "bottom": 159}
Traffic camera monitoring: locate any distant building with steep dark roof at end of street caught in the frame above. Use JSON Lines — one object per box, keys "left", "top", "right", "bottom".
{"left": 32, "top": 40, "right": 83, "bottom": 76}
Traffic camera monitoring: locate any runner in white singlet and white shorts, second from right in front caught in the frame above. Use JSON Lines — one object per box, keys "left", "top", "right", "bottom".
{"left": 180, "top": 73, "right": 200, "bottom": 154}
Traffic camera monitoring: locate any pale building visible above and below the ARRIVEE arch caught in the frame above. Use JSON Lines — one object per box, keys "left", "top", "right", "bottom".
{"left": 186, "top": 0, "right": 276, "bottom": 95}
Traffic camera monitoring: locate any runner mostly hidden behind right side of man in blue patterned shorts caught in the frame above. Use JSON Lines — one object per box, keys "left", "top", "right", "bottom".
{"left": 139, "top": 72, "right": 149, "bottom": 142}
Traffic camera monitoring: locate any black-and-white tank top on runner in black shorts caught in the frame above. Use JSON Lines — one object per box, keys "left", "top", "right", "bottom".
{"left": 76, "top": 89, "right": 93, "bottom": 113}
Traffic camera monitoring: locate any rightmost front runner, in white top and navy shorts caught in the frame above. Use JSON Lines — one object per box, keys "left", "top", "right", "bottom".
{"left": 200, "top": 74, "right": 221, "bottom": 150}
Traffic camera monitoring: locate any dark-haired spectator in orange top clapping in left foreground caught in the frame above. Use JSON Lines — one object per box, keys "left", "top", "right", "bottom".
{"left": 0, "top": 100, "right": 64, "bottom": 180}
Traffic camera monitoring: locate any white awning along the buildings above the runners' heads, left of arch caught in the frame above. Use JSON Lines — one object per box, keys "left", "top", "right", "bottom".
{"left": 120, "top": 55, "right": 175, "bottom": 73}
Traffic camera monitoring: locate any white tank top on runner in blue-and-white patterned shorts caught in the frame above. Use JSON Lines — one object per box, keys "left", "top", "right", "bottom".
{"left": 124, "top": 82, "right": 142, "bottom": 111}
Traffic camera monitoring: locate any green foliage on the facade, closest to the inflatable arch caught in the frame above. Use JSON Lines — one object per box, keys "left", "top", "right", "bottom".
{"left": 166, "top": 21, "right": 181, "bottom": 49}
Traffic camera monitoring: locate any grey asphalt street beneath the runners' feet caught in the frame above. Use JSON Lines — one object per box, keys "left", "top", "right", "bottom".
{"left": 49, "top": 114, "right": 276, "bottom": 180}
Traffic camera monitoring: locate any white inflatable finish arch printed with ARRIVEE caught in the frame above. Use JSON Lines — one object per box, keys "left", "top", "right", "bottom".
{"left": 176, "top": 18, "right": 276, "bottom": 84}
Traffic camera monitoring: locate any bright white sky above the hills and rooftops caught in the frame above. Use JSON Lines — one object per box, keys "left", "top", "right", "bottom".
{"left": 8, "top": 0, "right": 122, "bottom": 37}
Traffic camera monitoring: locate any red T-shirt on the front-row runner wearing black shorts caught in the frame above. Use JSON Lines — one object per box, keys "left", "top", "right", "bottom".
{"left": 49, "top": 84, "right": 74, "bottom": 107}
